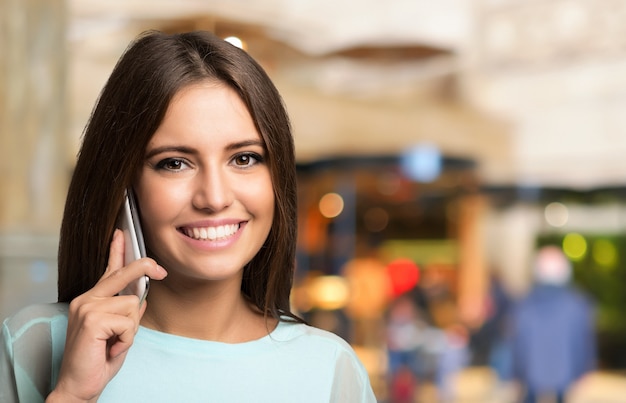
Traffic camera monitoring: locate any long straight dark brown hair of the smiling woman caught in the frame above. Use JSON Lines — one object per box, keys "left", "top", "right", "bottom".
{"left": 58, "top": 31, "right": 297, "bottom": 318}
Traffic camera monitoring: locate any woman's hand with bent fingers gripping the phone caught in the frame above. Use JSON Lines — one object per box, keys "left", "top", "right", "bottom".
{"left": 47, "top": 230, "right": 167, "bottom": 402}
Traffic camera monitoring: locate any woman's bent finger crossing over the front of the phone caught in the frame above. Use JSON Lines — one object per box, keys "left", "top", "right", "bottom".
{"left": 91, "top": 258, "right": 167, "bottom": 297}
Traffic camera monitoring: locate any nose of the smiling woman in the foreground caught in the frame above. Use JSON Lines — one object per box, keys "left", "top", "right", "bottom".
{"left": 192, "top": 169, "right": 234, "bottom": 212}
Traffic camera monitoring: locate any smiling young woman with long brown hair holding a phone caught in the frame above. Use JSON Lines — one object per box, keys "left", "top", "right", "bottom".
{"left": 0, "top": 32, "right": 375, "bottom": 403}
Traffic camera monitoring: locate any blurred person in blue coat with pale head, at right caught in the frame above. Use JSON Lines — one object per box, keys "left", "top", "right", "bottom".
{"left": 512, "top": 246, "right": 596, "bottom": 403}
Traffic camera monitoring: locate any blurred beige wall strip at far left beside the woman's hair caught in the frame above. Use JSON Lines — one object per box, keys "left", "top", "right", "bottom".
{"left": 0, "top": 0, "right": 70, "bottom": 316}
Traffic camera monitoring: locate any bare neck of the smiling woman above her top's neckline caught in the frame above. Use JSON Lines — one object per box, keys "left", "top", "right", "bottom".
{"left": 141, "top": 280, "right": 276, "bottom": 343}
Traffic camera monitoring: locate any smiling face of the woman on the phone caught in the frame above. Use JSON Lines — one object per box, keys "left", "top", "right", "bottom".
{"left": 135, "top": 82, "right": 274, "bottom": 282}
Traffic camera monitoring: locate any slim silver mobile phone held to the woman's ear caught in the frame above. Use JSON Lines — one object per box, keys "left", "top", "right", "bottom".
{"left": 119, "top": 189, "right": 150, "bottom": 303}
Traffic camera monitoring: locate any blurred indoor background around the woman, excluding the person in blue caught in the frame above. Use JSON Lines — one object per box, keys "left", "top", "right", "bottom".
{"left": 0, "top": 0, "right": 626, "bottom": 402}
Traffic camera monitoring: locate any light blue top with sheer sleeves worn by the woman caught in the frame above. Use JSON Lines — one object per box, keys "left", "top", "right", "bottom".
{"left": 0, "top": 304, "right": 376, "bottom": 403}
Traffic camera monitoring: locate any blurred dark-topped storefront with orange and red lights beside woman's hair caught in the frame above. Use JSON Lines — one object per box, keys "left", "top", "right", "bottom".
{"left": 294, "top": 152, "right": 488, "bottom": 395}
